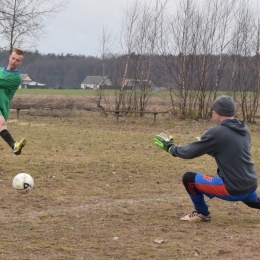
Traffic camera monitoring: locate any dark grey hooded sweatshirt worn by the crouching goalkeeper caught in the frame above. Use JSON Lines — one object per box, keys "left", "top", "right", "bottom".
{"left": 170, "top": 119, "right": 257, "bottom": 195}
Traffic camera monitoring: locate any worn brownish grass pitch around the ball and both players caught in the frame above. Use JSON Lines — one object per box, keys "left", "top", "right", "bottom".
{"left": 0, "top": 106, "right": 260, "bottom": 260}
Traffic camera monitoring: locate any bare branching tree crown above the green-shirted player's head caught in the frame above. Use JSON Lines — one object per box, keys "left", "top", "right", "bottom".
{"left": 0, "top": 0, "right": 69, "bottom": 52}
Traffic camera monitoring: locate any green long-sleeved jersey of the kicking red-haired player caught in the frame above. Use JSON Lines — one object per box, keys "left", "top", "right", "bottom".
{"left": 0, "top": 67, "right": 22, "bottom": 121}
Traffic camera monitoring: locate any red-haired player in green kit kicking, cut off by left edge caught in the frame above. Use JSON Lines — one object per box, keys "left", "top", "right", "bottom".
{"left": 0, "top": 49, "right": 26, "bottom": 155}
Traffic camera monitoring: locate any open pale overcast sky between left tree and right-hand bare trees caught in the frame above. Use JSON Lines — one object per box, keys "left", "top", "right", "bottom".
{"left": 37, "top": 0, "right": 260, "bottom": 56}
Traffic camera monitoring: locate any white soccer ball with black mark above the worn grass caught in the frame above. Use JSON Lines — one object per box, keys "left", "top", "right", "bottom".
{"left": 13, "top": 173, "right": 34, "bottom": 193}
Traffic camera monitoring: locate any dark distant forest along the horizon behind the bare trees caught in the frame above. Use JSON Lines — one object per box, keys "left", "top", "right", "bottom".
{"left": 0, "top": 51, "right": 257, "bottom": 91}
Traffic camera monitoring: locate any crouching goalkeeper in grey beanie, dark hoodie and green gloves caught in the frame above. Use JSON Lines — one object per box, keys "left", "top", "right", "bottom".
{"left": 154, "top": 96, "right": 260, "bottom": 222}
